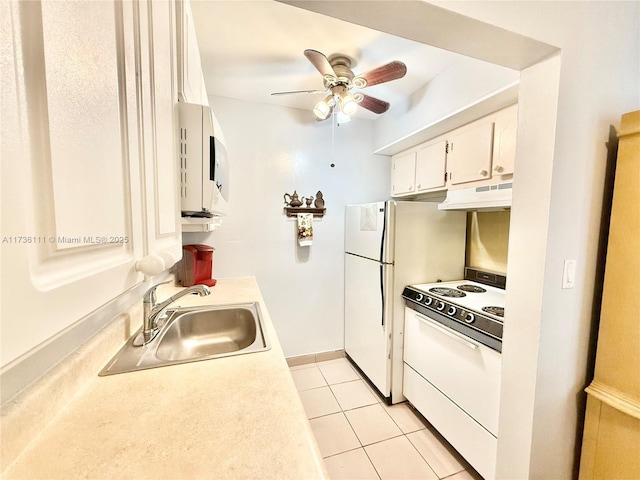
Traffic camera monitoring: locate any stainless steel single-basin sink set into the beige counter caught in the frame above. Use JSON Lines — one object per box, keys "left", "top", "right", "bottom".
{"left": 99, "top": 302, "right": 271, "bottom": 376}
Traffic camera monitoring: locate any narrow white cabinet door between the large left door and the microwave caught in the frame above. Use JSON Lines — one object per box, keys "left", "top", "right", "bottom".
{"left": 138, "top": 0, "right": 182, "bottom": 268}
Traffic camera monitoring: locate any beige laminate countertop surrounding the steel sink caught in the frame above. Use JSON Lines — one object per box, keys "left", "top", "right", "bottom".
{"left": 3, "top": 278, "right": 327, "bottom": 480}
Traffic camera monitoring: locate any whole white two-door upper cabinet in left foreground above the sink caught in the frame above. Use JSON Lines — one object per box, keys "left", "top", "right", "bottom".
{"left": 1, "top": 0, "right": 181, "bottom": 365}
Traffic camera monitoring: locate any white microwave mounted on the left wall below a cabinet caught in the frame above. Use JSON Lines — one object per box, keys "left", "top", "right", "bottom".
{"left": 178, "top": 102, "right": 229, "bottom": 218}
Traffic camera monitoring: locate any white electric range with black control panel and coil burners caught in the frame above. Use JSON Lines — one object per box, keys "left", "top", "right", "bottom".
{"left": 402, "top": 269, "right": 506, "bottom": 478}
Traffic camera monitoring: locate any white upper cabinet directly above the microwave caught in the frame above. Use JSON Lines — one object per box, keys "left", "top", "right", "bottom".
{"left": 176, "top": 0, "right": 209, "bottom": 105}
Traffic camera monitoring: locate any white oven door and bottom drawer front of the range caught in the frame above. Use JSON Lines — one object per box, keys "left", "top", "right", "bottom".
{"left": 403, "top": 308, "right": 502, "bottom": 478}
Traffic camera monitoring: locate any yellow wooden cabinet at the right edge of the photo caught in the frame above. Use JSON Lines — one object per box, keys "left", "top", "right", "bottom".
{"left": 580, "top": 111, "right": 640, "bottom": 480}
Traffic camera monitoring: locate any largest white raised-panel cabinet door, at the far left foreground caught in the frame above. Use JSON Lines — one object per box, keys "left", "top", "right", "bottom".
{"left": 0, "top": 1, "right": 143, "bottom": 365}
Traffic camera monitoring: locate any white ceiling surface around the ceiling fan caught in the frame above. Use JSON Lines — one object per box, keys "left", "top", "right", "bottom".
{"left": 191, "top": 0, "right": 464, "bottom": 119}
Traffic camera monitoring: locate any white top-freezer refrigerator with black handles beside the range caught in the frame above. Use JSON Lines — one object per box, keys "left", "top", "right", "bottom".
{"left": 344, "top": 200, "right": 466, "bottom": 404}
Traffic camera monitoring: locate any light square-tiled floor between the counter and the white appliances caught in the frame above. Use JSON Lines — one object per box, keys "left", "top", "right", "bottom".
{"left": 291, "top": 358, "right": 482, "bottom": 480}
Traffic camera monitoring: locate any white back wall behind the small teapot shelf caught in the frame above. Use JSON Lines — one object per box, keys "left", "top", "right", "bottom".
{"left": 184, "top": 96, "right": 390, "bottom": 356}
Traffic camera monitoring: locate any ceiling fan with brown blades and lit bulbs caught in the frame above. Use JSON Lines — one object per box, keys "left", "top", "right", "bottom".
{"left": 271, "top": 49, "right": 407, "bottom": 120}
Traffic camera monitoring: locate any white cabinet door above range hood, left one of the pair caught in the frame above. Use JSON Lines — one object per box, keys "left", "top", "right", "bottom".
{"left": 447, "top": 119, "right": 493, "bottom": 185}
